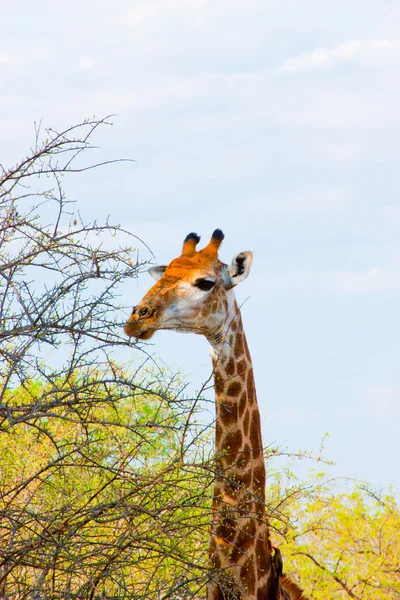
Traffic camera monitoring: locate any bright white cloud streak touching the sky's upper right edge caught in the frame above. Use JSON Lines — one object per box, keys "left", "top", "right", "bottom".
{"left": 274, "top": 39, "right": 400, "bottom": 73}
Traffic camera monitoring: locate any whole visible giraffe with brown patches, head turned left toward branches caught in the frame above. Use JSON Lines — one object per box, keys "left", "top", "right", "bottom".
{"left": 124, "top": 229, "right": 306, "bottom": 600}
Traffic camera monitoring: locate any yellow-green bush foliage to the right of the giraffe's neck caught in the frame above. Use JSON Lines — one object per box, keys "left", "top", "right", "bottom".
{"left": 270, "top": 477, "right": 400, "bottom": 600}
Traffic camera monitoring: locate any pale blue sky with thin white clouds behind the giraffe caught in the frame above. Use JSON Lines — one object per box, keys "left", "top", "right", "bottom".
{"left": 0, "top": 0, "right": 400, "bottom": 492}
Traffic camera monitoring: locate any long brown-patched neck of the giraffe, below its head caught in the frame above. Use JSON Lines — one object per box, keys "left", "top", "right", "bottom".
{"left": 207, "top": 302, "right": 271, "bottom": 600}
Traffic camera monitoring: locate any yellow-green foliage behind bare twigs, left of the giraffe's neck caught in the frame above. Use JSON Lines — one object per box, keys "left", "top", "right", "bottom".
{"left": 0, "top": 373, "right": 210, "bottom": 598}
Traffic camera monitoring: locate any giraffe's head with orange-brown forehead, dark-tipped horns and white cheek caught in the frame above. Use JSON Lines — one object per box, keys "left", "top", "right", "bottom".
{"left": 124, "top": 229, "right": 253, "bottom": 341}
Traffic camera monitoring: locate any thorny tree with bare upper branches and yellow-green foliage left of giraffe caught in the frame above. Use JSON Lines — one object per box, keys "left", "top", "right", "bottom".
{"left": 0, "top": 120, "right": 212, "bottom": 599}
